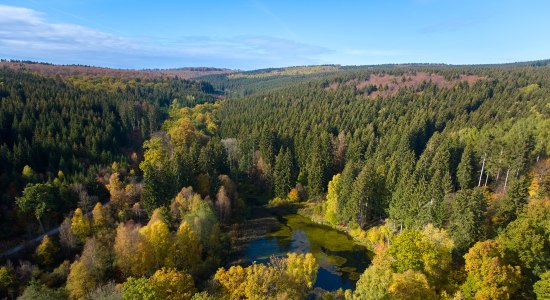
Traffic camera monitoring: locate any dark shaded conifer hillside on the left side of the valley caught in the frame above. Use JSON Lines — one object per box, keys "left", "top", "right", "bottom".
{"left": 0, "top": 68, "right": 215, "bottom": 237}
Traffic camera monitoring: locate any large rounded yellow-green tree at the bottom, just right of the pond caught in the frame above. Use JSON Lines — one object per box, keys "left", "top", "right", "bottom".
{"left": 353, "top": 224, "right": 454, "bottom": 299}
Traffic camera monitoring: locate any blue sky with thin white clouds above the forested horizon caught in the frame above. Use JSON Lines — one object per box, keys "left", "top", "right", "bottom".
{"left": 0, "top": 0, "right": 550, "bottom": 70}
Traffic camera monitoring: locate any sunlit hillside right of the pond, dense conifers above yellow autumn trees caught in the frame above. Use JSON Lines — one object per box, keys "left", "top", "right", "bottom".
{"left": 219, "top": 66, "right": 550, "bottom": 299}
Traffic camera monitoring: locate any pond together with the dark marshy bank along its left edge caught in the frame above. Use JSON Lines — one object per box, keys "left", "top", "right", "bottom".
{"left": 229, "top": 200, "right": 371, "bottom": 290}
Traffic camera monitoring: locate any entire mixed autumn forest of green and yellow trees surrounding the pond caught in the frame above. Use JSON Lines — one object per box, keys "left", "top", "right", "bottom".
{"left": 0, "top": 61, "right": 550, "bottom": 300}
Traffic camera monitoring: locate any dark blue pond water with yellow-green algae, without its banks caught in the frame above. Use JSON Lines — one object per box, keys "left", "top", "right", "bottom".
{"left": 244, "top": 214, "right": 370, "bottom": 291}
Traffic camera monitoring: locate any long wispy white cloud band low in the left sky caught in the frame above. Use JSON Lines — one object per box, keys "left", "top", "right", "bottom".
{"left": 0, "top": 5, "right": 330, "bottom": 69}
